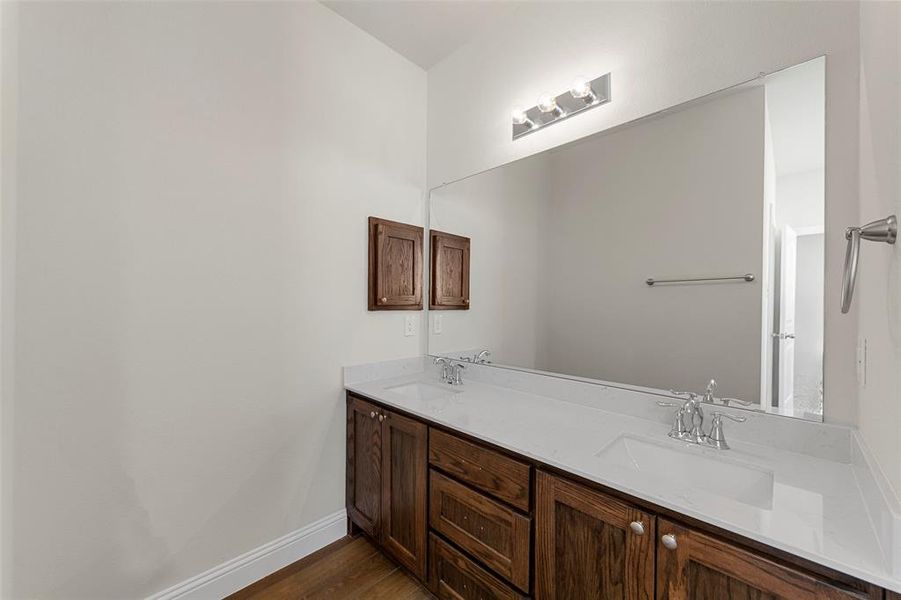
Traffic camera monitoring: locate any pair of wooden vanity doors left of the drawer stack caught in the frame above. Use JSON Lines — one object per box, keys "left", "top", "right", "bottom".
{"left": 346, "top": 397, "right": 428, "bottom": 580}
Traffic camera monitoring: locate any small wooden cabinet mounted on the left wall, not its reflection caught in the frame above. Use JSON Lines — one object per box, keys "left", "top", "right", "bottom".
{"left": 369, "top": 217, "right": 423, "bottom": 310}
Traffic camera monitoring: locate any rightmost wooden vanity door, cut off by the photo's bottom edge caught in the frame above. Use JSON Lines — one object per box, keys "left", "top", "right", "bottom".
{"left": 657, "top": 519, "right": 872, "bottom": 600}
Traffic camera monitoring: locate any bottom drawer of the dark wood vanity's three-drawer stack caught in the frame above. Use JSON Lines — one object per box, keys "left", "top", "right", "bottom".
{"left": 429, "top": 533, "right": 525, "bottom": 600}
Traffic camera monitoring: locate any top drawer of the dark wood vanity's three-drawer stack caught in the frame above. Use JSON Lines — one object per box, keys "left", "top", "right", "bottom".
{"left": 429, "top": 428, "right": 531, "bottom": 512}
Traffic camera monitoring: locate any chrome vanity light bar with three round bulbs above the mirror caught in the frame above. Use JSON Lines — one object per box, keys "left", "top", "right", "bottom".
{"left": 511, "top": 73, "right": 610, "bottom": 140}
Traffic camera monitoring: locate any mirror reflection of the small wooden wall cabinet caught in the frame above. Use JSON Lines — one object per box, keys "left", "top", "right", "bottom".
{"left": 429, "top": 230, "right": 470, "bottom": 310}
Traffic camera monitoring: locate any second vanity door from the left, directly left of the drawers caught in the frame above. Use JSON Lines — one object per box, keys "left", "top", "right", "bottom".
{"left": 380, "top": 412, "right": 428, "bottom": 580}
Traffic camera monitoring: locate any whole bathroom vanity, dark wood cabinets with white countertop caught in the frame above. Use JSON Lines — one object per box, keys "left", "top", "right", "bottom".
{"left": 347, "top": 366, "right": 901, "bottom": 599}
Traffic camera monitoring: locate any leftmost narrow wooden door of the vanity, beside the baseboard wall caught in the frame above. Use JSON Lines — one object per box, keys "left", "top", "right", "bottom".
{"left": 346, "top": 397, "right": 382, "bottom": 538}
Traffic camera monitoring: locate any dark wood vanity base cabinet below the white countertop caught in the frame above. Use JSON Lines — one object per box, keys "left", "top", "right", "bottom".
{"left": 347, "top": 394, "right": 888, "bottom": 600}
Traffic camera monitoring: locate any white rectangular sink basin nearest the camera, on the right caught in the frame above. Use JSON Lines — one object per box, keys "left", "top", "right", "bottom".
{"left": 595, "top": 435, "right": 773, "bottom": 509}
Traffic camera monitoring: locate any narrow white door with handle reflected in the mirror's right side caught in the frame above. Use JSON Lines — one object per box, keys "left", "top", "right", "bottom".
{"left": 776, "top": 225, "right": 798, "bottom": 414}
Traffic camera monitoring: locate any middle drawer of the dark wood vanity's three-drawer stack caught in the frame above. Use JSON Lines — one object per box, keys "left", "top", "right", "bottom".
{"left": 429, "top": 469, "right": 531, "bottom": 590}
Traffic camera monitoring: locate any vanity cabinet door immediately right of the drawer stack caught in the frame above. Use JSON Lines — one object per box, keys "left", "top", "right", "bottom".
{"left": 535, "top": 471, "right": 656, "bottom": 600}
